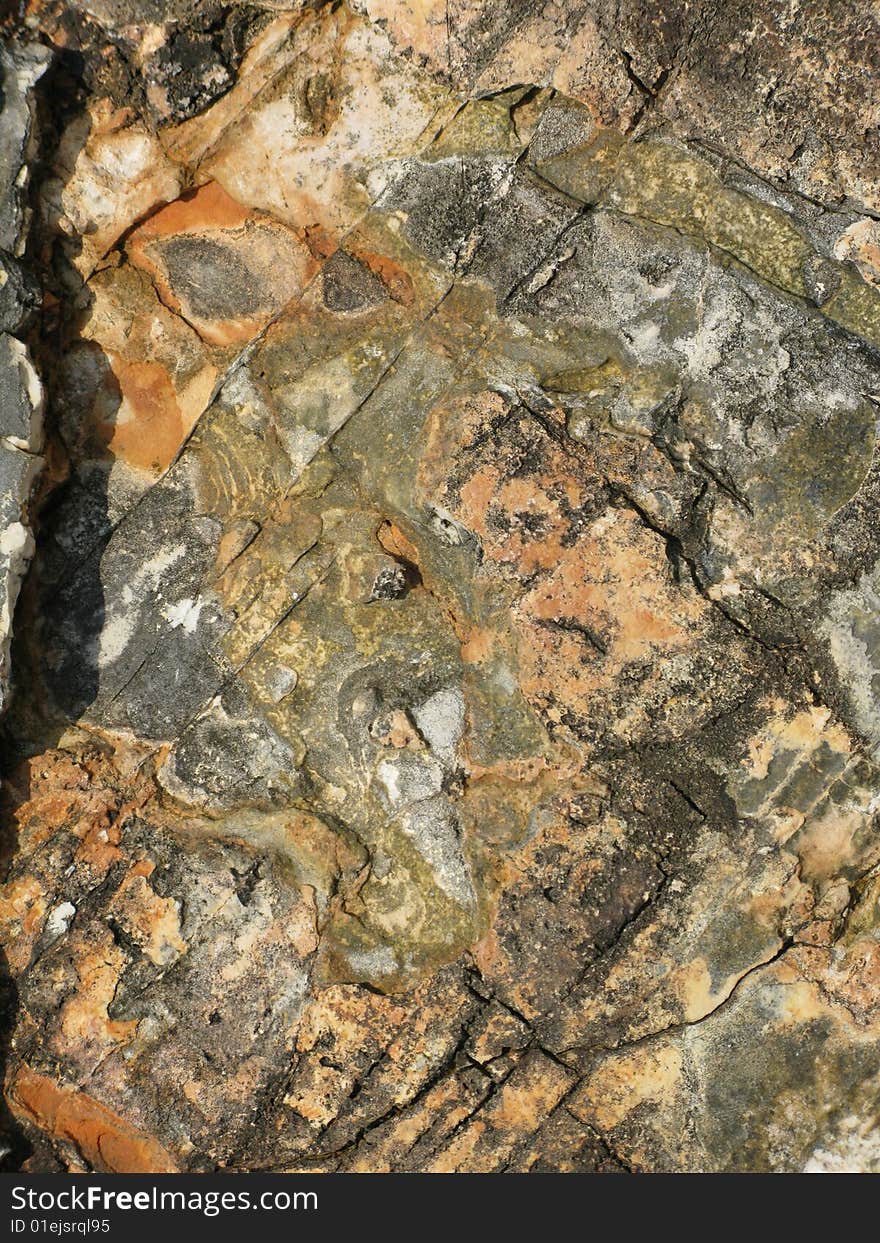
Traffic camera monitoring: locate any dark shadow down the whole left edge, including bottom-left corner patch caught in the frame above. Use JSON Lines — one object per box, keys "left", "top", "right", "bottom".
{"left": 0, "top": 29, "right": 121, "bottom": 1172}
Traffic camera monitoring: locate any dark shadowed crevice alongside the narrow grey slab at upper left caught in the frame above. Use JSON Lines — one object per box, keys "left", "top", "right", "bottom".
{"left": 20, "top": 31, "right": 121, "bottom": 725}
